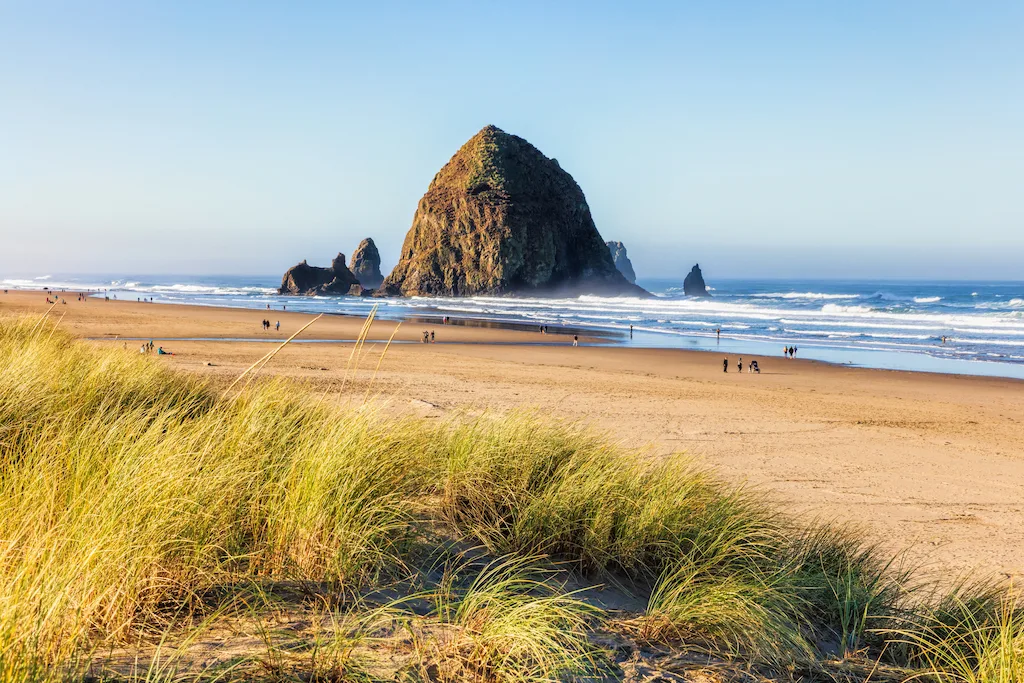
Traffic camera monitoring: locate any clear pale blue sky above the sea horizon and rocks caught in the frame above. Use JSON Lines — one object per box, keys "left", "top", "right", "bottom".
{"left": 0, "top": 0, "right": 1024, "bottom": 280}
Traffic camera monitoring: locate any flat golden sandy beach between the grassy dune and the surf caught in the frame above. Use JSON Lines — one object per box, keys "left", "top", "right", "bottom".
{"left": 0, "top": 291, "right": 1024, "bottom": 580}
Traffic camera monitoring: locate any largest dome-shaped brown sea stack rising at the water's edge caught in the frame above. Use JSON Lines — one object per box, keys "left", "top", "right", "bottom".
{"left": 377, "top": 126, "right": 647, "bottom": 296}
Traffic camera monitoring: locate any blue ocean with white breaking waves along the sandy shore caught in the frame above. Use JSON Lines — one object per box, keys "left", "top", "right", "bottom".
{"left": 8, "top": 275, "right": 1024, "bottom": 379}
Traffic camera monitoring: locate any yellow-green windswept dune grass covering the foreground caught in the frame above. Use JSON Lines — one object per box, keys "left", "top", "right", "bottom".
{"left": 0, "top": 321, "right": 1024, "bottom": 683}
